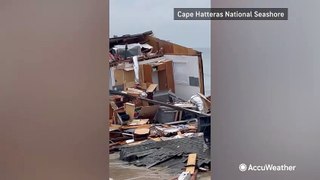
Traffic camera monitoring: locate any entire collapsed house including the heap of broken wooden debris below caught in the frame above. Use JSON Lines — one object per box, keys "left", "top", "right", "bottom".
{"left": 109, "top": 31, "right": 211, "bottom": 177}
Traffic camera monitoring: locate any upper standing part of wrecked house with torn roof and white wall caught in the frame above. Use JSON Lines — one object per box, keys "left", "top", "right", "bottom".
{"left": 109, "top": 31, "right": 204, "bottom": 99}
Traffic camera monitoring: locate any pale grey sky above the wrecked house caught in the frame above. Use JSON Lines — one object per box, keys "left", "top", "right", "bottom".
{"left": 109, "top": 0, "right": 210, "bottom": 48}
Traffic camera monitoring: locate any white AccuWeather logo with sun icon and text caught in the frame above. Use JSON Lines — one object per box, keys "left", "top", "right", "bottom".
{"left": 239, "top": 163, "right": 296, "bottom": 172}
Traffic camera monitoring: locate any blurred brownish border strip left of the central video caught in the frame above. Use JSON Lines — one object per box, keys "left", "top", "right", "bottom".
{"left": 0, "top": 0, "right": 108, "bottom": 180}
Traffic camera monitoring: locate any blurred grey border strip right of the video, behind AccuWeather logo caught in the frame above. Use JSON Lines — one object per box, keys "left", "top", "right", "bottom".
{"left": 211, "top": 0, "right": 320, "bottom": 180}
